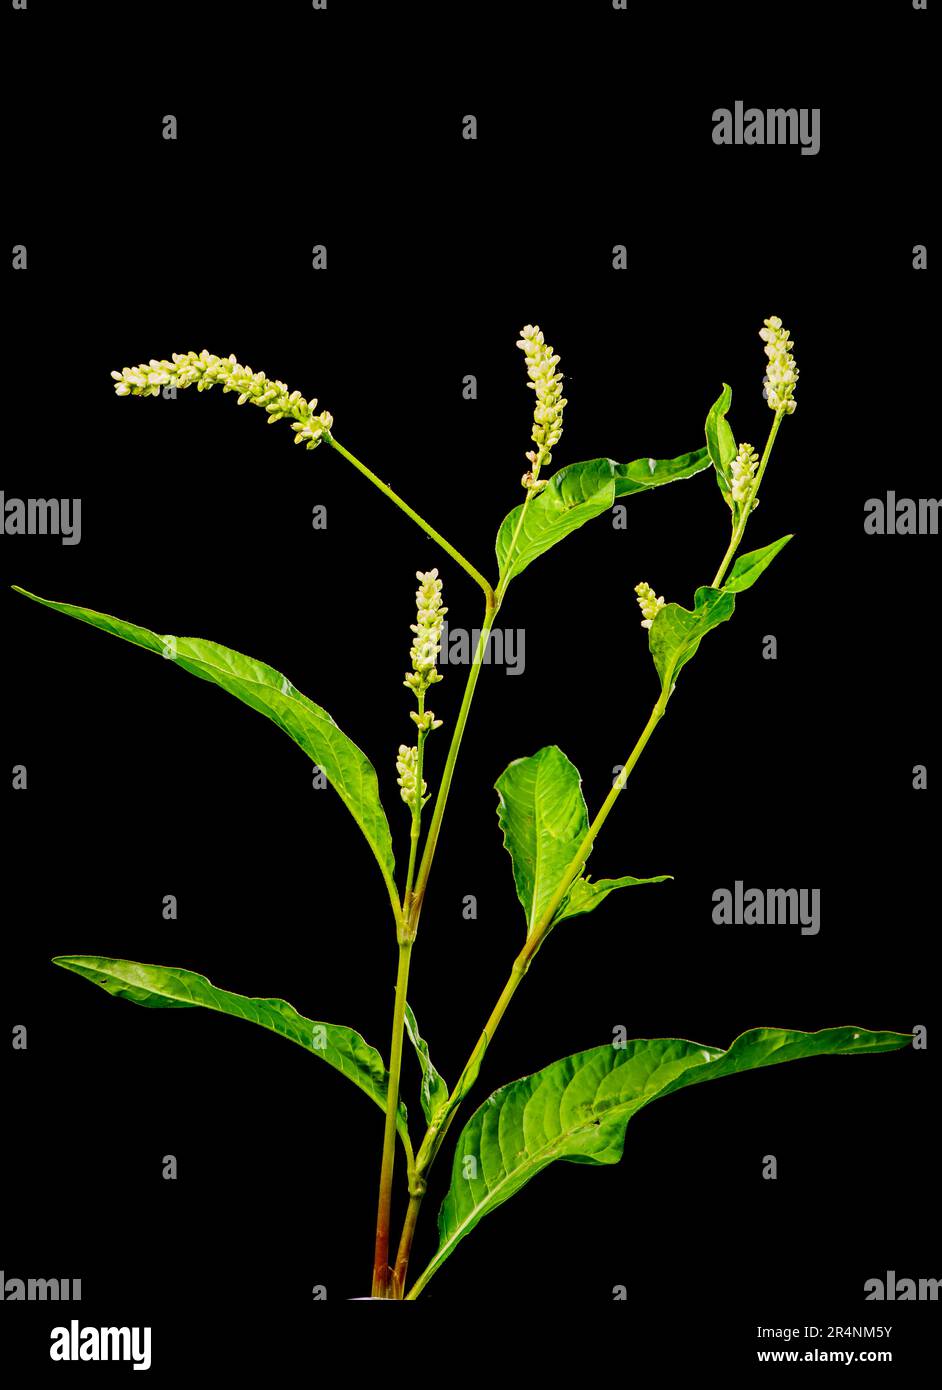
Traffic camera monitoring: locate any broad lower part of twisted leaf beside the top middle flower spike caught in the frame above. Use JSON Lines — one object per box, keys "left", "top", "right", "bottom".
{"left": 496, "top": 459, "right": 615, "bottom": 582}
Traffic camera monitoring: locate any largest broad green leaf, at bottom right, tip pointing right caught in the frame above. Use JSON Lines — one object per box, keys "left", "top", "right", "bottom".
{"left": 410, "top": 1029, "right": 911, "bottom": 1297}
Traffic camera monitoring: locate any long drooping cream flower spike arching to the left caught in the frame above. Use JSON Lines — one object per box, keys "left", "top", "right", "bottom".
{"left": 111, "top": 349, "right": 333, "bottom": 449}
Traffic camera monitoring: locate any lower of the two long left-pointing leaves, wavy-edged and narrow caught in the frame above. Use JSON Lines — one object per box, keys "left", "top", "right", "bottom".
{"left": 53, "top": 956, "right": 411, "bottom": 1155}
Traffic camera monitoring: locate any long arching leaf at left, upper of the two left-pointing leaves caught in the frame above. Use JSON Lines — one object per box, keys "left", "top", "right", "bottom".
{"left": 14, "top": 585, "right": 396, "bottom": 898}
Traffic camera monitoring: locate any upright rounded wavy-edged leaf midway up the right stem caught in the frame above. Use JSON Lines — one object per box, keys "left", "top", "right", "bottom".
{"left": 495, "top": 744, "right": 589, "bottom": 937}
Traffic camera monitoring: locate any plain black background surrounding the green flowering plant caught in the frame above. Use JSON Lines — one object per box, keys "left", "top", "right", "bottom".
{"left": 0, "top": 3, "right": 938, "bottom": 1376}
